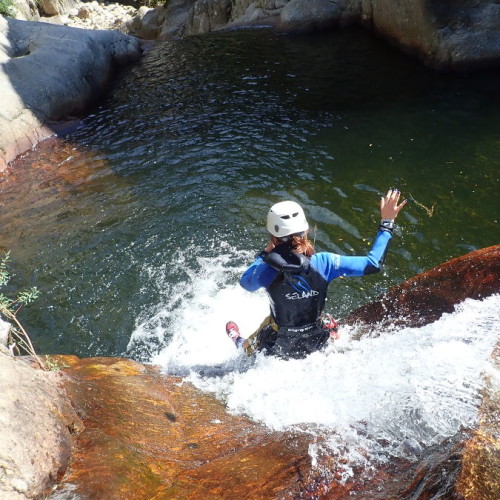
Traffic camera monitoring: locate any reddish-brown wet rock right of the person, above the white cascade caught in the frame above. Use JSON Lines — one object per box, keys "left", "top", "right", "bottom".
{"left": 344, "top": 245, "right": 500, "bottom": 327}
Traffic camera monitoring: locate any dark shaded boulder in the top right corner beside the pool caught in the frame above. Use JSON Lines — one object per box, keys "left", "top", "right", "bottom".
{"left": 362, "top": 0, "right": 500, "bottom": 70}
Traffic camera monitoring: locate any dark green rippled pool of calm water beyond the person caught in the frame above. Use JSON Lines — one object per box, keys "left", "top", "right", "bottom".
{"left": 0, "top": 30, "right": 500, "bottom": 358}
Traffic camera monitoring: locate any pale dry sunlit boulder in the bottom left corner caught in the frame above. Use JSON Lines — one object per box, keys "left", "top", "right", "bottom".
{"left": 0, "top": 352, "right": 82, "bottom": 500}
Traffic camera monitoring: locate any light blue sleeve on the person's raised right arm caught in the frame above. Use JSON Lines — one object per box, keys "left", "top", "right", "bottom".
{"left": 311, "top": 231, "right": 392, "bottom": 282}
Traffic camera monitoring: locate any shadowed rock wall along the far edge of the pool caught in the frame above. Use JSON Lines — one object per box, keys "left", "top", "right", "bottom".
{"left": 131, "top": 0, "right": 500, "bottom": 71}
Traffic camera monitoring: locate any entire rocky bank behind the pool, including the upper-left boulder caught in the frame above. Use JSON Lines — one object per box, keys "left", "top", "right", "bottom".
{"left": 0, "top": 0, "right": 500, "bottom": 171}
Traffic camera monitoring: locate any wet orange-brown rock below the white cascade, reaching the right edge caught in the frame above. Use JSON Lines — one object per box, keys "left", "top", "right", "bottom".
{"left": 50, "top": 350, "right": 500, "bottom": 500}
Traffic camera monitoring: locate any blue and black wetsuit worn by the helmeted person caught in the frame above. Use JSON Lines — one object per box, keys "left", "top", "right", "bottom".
{"left": 240, "top": 228, "right": 392, "bottom": 358}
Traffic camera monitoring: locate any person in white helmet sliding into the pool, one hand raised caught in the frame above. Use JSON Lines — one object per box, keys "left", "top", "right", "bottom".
{"left": 226, "top": 189, "right": 407, "bottom": 359}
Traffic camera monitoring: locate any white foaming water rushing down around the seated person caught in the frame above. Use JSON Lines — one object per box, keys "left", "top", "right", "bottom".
{"left": 130, "top": 250, "right": 500, "bottom": 464}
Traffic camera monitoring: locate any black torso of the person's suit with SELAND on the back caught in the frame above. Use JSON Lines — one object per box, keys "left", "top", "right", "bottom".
{"left": 264, "top": 243, "right": 328, "bottom": 328}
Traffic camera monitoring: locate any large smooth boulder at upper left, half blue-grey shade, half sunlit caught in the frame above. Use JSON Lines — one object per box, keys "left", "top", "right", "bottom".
{"left": 0, "top": 16, "right": 141, "bottom": 171}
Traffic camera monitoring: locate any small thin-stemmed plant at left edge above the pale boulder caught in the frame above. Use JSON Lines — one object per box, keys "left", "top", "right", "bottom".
{"left": 0, "top": 252, "right": 47, "bottom": 370}
